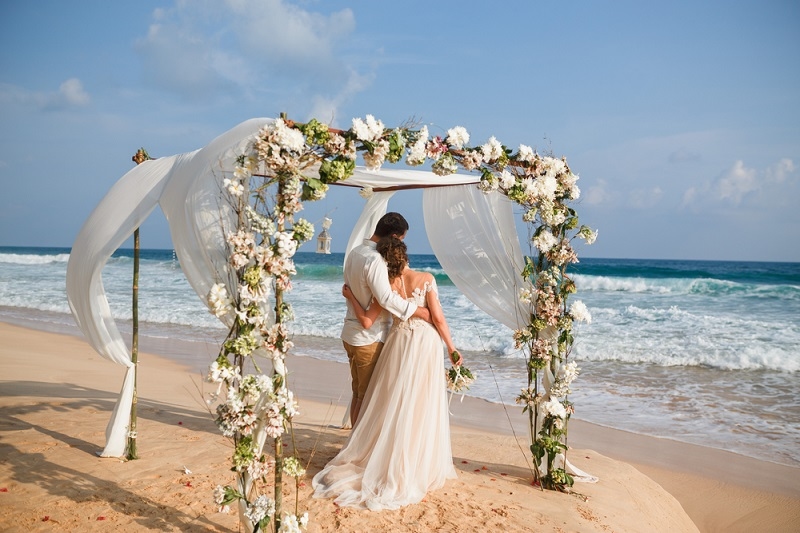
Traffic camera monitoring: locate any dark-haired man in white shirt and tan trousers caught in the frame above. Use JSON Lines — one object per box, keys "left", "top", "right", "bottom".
{"left": 341, "top": 213, "right": 430, "bottom": 425}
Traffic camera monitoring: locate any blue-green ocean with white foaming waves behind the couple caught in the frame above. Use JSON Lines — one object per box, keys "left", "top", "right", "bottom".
{"left": 0, "top": 247, "right": 800, "bottom": 466}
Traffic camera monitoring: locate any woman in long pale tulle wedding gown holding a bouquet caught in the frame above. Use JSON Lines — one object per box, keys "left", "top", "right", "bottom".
{"left": 312, "top": 237, "right": 463, "bottom": 510}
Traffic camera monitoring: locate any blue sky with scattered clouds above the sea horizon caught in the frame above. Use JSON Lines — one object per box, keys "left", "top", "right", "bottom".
{"left": 0, "top": 0, "right": 800, "bottom": 261}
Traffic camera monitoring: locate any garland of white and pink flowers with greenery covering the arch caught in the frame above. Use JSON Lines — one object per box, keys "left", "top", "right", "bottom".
{"left": 207, "top": 115, "right": 596, "bottom": 532}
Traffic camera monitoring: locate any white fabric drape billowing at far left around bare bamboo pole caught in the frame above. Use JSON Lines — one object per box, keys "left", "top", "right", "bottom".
{"left": 66, "top": 118, "right": 271, "bottom": 457}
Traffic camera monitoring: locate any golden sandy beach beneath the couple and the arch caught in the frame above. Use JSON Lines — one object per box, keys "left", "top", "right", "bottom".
{"left": 0, "top": 323, "right": 800, "bottom": 532}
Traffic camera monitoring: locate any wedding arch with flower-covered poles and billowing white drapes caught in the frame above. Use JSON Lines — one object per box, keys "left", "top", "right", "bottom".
{"left": 67, "top": 115, "right": 596, "bottom": 531}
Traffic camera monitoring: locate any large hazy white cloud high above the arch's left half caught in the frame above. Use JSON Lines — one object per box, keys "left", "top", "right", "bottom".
{"left": 136, "top": 0, "right": 371, "bottom": 113}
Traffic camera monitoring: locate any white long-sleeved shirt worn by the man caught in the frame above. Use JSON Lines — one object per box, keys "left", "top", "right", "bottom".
{"left": 341, "top": 239, "right": 417, "bottom": 346}
